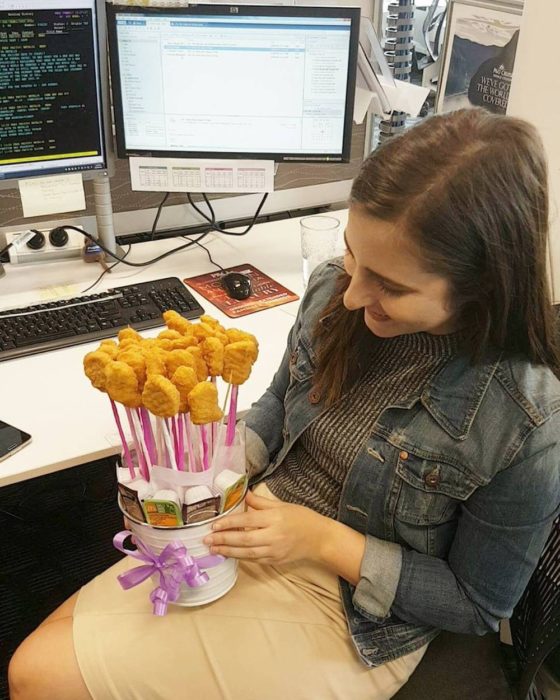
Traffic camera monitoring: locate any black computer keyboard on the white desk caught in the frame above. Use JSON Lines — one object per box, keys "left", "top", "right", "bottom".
{"left": 0, "top": 277, "right": 204, "bottom": 362}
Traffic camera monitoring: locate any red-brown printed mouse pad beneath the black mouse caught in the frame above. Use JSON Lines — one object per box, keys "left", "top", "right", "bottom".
{"left": 183, "top": 263, "right": 299, "bottom": 318}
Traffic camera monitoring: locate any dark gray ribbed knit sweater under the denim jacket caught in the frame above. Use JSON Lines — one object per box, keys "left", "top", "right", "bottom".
{"left": 266, "top": 333, "right": 458, "bottom": 518}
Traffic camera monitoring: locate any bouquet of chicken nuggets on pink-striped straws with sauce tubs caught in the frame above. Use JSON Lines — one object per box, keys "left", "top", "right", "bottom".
{"left": 84, "top": 310, "right": 258, "bottom": 528}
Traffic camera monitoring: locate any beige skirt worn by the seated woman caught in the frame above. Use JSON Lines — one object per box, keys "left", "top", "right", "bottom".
{"left": 74, "top": 486, "right": 427, "bottom": 700}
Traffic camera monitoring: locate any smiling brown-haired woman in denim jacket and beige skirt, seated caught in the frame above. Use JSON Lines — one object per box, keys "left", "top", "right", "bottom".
{"left": 10, "top": 110, "right": 560, "bottom": 700}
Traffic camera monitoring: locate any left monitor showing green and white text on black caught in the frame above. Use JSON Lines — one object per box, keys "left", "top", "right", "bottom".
{"left": 0, "top": 0, "right": 107, "bottom": 186}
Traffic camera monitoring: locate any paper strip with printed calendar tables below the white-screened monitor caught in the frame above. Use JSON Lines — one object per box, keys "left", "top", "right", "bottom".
{"left": 130, "top": 158, "right": 274, "bottom": 192}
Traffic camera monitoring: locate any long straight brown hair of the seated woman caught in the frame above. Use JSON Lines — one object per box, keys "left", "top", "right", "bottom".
{"left": 314, "top": 109, "right": 560, "bottom": 404}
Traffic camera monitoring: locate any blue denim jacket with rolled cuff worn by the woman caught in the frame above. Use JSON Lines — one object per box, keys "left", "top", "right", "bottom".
{"left": 245, "top": 261, "right": 560, "bottom": 666}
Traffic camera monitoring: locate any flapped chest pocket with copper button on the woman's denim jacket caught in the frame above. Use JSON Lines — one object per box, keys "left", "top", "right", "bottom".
{"left": 395, "top": 451, "right": 480, "bottom": 525}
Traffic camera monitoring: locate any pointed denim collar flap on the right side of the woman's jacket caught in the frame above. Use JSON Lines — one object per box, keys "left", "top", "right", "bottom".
{"left": 420, "top": 353, "right": 500, "bottom": 440}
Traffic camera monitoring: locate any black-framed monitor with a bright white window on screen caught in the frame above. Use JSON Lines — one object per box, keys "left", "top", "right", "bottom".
{"left": 107, "top": 5, "right": 360, "bottom": 162}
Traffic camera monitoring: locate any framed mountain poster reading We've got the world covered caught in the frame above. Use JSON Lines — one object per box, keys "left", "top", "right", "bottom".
{"left": 436, "top": 0, "right": 522, "bottom": 114}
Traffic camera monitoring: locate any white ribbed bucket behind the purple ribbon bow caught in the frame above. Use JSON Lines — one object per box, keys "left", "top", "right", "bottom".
{"left": 118, "top": 486, "right": 245, "bottom": 607}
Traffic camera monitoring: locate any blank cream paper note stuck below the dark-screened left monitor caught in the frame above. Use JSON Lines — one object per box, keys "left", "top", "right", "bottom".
{"left": 19, "top": 173, "right": 86, "bottom": 216}
